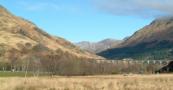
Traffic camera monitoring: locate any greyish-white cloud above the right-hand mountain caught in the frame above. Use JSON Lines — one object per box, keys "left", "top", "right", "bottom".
{"left": 92, "top": 0, "right": 173, "bottom": 17}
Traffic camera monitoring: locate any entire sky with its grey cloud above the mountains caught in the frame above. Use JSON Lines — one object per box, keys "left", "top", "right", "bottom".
{"left": 0, "top": 0, "right": 169, "bottom": 42}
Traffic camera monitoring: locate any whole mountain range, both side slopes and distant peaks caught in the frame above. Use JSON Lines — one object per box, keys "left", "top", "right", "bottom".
{"left": 0, "top": 6, "right": 173, "bottom": 62}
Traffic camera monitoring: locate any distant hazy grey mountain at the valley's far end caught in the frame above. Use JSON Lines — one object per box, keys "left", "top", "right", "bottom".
{"left": 76, "top": 39, "right": 121, "bottom": 53}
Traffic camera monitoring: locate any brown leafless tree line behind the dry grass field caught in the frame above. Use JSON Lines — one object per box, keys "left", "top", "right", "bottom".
{"left": 0, "top": 44, "right": 166, "bottom": 76}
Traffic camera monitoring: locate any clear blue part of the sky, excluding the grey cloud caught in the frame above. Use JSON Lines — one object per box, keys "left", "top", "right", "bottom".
{"left": 0, "top": 0, "right": 153, "bottom": 42}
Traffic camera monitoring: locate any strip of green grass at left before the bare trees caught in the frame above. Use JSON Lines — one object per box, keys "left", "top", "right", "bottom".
{"left": 0, "top": 71, "right": 33, "bottom": 77}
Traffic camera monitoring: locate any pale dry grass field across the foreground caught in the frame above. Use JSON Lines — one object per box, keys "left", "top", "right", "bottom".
{"left": 0, "top": 75, "right": 173, "bottom": 90}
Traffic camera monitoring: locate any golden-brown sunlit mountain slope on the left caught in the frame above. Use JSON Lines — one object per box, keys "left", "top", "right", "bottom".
{"left": 0, "top": 6, "right": 101, "bottom": 62}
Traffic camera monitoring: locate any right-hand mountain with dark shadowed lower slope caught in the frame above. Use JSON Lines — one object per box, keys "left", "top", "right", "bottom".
{"left": 98, "top": 17, "right": 173, "bottom": 60}
